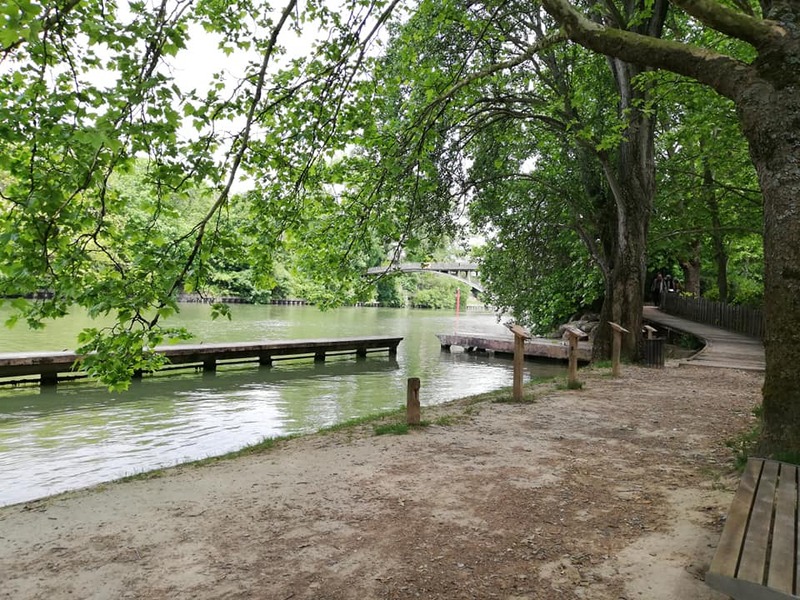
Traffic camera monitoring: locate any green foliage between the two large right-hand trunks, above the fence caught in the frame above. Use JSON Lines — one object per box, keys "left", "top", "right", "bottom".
{"left": 648, "top": 68, "right": 763, "bottom": 304}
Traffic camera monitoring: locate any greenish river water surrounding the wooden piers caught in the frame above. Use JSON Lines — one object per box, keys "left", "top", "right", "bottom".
{"left": 0, "top": 304, "right": 564, "bottom": 505}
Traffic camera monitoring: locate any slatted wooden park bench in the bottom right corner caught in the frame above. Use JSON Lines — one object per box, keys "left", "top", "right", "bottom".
{"left": 706, "top": 458, "right": 800, "bottom": 600}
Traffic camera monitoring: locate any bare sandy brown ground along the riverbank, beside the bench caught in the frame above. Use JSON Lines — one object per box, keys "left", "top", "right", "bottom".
{"left": 0, "top": 365, "right": 763, "bottom": 600}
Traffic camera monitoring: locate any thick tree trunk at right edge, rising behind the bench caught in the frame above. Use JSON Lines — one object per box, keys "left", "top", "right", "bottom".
{"left": 737, "top": 79, "right": 800, "bottom": 459}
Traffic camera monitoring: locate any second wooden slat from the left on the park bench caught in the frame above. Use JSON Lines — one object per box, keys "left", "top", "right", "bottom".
{"left": 736, "top": 461, "right": 778, "bottom": 583}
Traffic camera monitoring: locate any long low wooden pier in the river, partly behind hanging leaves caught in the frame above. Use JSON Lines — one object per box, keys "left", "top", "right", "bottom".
{"left": 0, "top": 337, "right": 403, "bottom": 384}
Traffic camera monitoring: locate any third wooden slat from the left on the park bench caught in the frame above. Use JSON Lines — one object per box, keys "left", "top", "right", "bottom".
{"left": 767, "top": 464, "right": 797, "bottom": 594}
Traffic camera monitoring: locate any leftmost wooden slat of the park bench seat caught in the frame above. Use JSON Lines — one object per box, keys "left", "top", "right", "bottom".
{"left": 709, "top": 461, "right": 761, "bottom": 577}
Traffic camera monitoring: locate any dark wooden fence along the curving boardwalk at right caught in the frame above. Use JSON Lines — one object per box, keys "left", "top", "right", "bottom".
{"left": 661, "top": 294, "right": 764, "bottom": 339}
